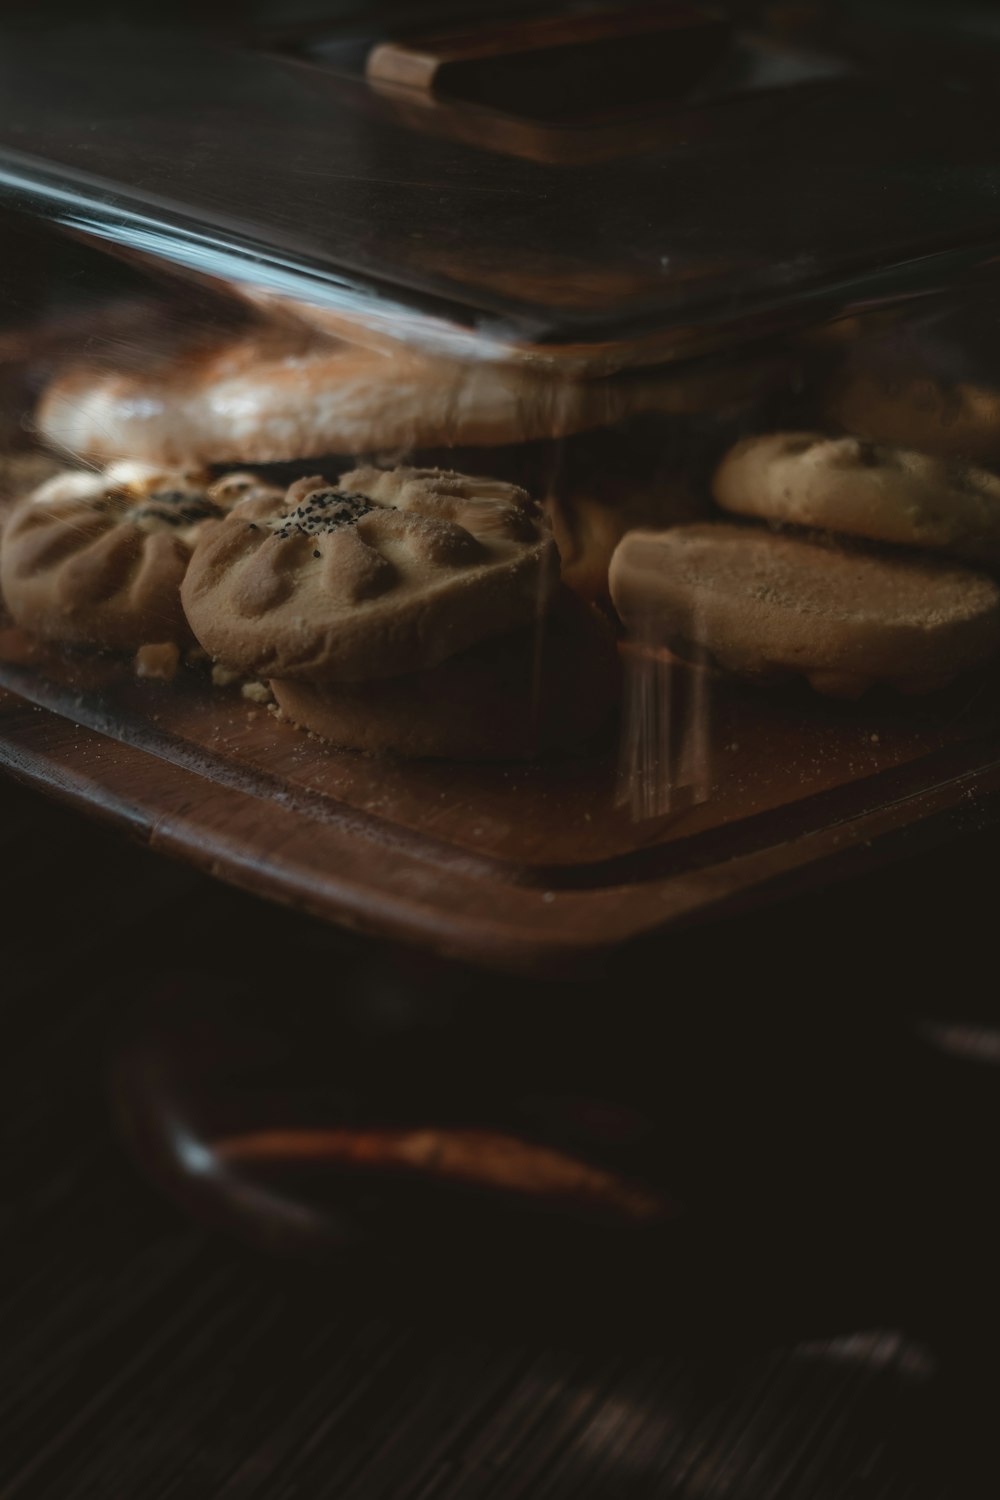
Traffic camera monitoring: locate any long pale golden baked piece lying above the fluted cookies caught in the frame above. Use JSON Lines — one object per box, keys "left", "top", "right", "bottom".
{"left": 36, "top": 332, "right": 680, "bottom": 464}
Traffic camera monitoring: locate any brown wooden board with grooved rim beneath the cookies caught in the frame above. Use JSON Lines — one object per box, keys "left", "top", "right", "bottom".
{"left": 0, "top": 629, "right": 1000, "bottom": 972}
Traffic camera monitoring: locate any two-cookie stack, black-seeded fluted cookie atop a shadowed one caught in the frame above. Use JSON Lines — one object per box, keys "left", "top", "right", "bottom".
{"left": 181, "top": 468, "right": 618, "bottom": 759}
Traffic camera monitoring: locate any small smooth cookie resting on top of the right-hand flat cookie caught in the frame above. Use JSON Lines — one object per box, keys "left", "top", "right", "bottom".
{"left": 714, "top": 432, "right": 1000, "bottom": 563}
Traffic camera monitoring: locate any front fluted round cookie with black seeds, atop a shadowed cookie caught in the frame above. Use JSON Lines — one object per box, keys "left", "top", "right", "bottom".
{"left": 183, "top": 468, "right": 558, "bottom": 683}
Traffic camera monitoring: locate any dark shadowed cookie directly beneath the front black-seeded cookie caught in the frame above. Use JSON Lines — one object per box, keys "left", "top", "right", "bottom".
{"left": 271, "top": 587, "right": 619, "bottom": 761}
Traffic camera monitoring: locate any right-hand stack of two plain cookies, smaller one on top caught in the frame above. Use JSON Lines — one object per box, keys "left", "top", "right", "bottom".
{"left": 610, "top": 432, "right": 1000, "bottom": 698}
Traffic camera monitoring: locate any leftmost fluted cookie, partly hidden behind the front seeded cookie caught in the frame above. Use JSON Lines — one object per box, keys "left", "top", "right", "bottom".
{"left": 0, "top": 462, "right": 277, "bottom": 651}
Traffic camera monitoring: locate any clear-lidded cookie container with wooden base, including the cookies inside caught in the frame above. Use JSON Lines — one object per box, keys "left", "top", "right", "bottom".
{"left": 0, "top": 6, "right": 1000, "bottom": 968}
